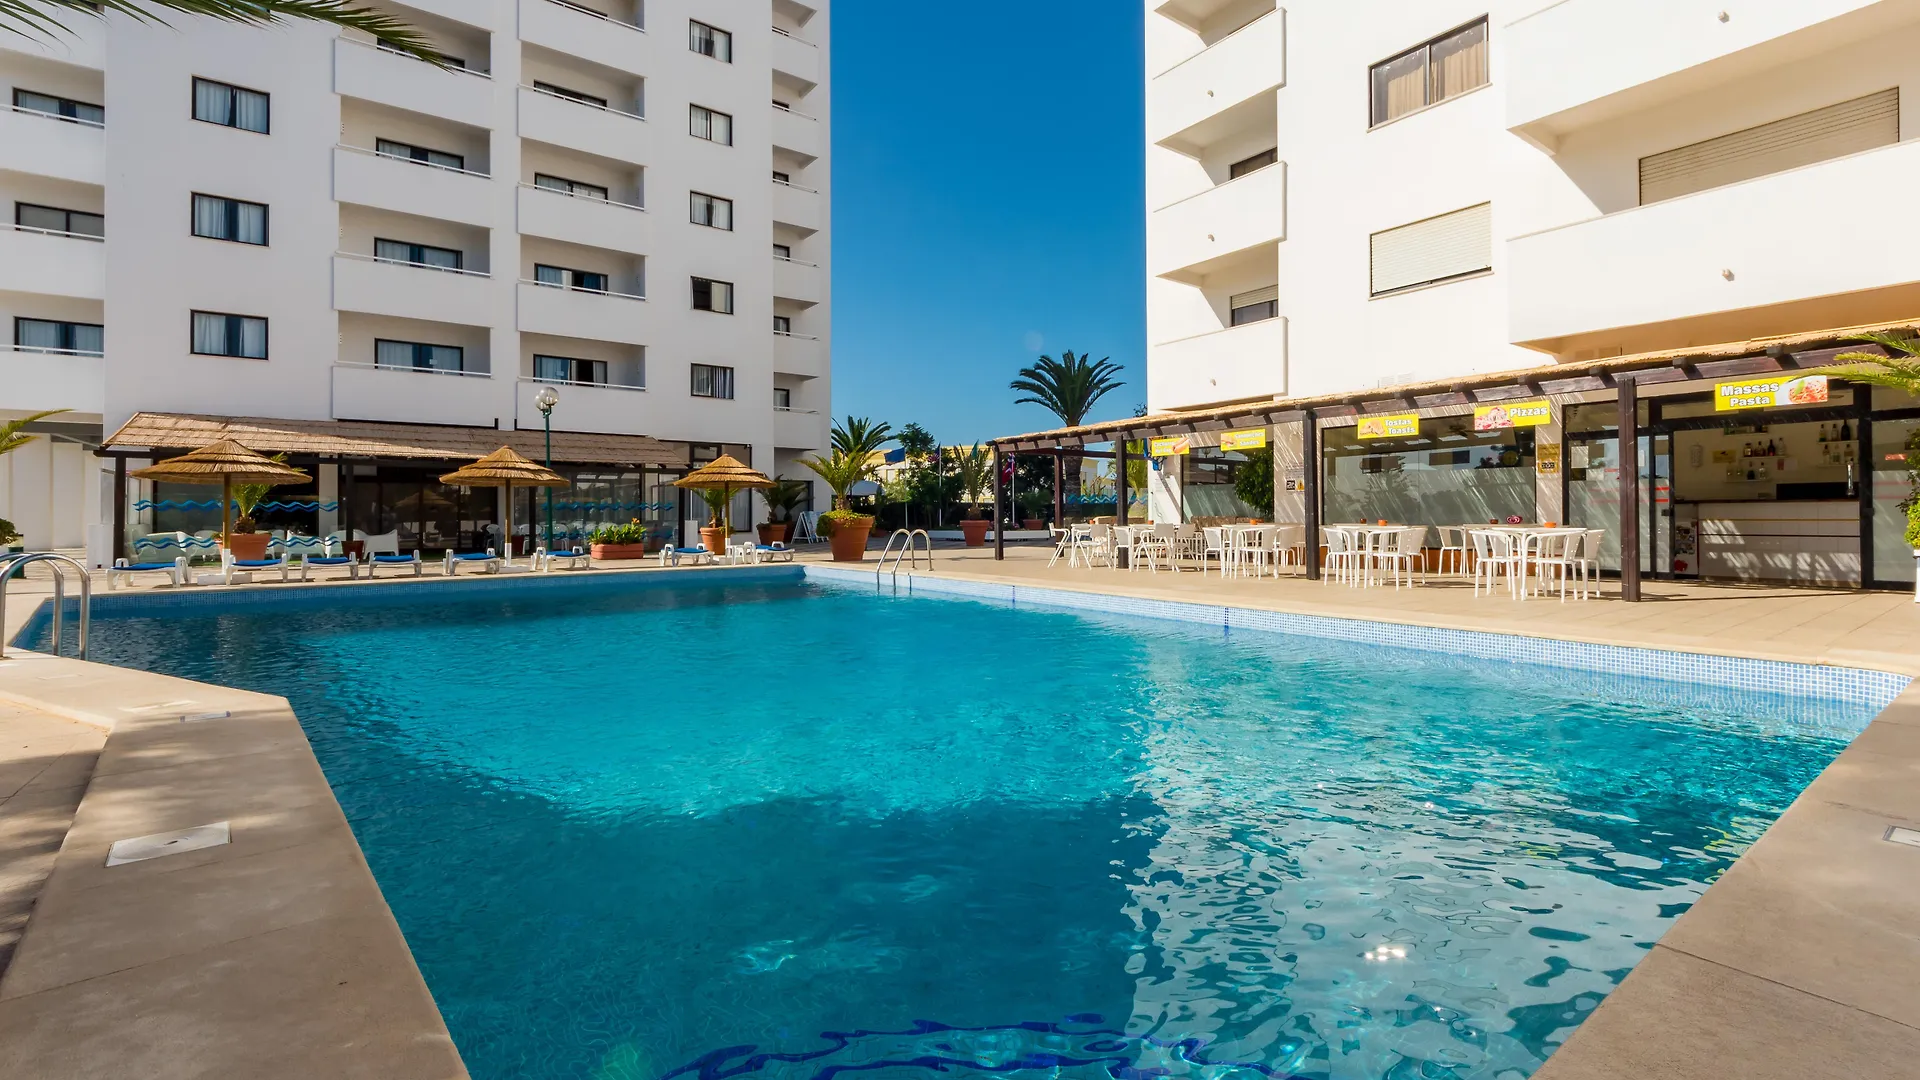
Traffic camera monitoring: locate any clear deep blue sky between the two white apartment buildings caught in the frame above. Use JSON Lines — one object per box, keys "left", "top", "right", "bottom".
{"left": 833, "top": 0, "right": 1146, "bottom": 442}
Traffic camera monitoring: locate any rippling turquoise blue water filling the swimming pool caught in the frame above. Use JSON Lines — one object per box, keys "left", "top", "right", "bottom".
{"left": 52, "top": 578, "right": 1874, "bottom": 1080}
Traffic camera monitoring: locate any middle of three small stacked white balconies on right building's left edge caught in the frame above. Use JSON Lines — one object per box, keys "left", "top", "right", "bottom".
{"left": 1146, "top": 161, "right": 1286, "bottom": 284}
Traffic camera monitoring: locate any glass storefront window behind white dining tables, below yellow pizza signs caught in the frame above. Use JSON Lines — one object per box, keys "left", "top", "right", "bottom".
{"left": 1321, "top": 417, "right": 1538, "bottom": 525}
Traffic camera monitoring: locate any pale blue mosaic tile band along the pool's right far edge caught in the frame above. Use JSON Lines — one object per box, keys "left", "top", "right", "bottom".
{"left": 806, "top": 565, "right": 1910, "bottom": 707}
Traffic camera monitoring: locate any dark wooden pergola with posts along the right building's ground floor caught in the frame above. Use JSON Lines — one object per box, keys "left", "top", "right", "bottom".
{"left": 991, "top": 319, "right": 1920, "bottom": 601}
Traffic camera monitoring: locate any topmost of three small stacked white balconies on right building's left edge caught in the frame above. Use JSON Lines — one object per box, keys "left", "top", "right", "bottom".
{"left": 1146, "top": 10, "right": 1286, "bottom": 152}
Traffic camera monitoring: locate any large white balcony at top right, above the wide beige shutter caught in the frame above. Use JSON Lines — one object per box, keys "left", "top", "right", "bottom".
{"left": 1501, "top": 0, "right": 1912, "bottom": 152}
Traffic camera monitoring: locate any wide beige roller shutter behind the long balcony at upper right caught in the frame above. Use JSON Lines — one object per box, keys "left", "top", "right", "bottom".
{"left": 1640, "top": 86, "right": 1901, "bottom": 206}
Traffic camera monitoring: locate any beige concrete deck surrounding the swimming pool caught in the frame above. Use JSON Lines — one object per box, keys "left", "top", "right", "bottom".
{"left": 0, "top": 548, "right": 1920, "bottom": 1080}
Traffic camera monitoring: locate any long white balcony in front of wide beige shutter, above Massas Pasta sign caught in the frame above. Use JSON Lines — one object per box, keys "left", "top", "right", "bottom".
{"left": 1505, "top": 140, "right": 1920, "bottom": 352}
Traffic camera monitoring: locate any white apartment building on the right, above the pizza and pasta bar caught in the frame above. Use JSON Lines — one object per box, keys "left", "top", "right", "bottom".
{"left": 1144, "top": 0, "right": 1920, "bottom": 580}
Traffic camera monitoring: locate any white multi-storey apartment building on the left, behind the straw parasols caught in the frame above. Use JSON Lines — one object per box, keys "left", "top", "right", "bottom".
{"left": 0, "top": 0, "right": 831, "bottom": 557}
